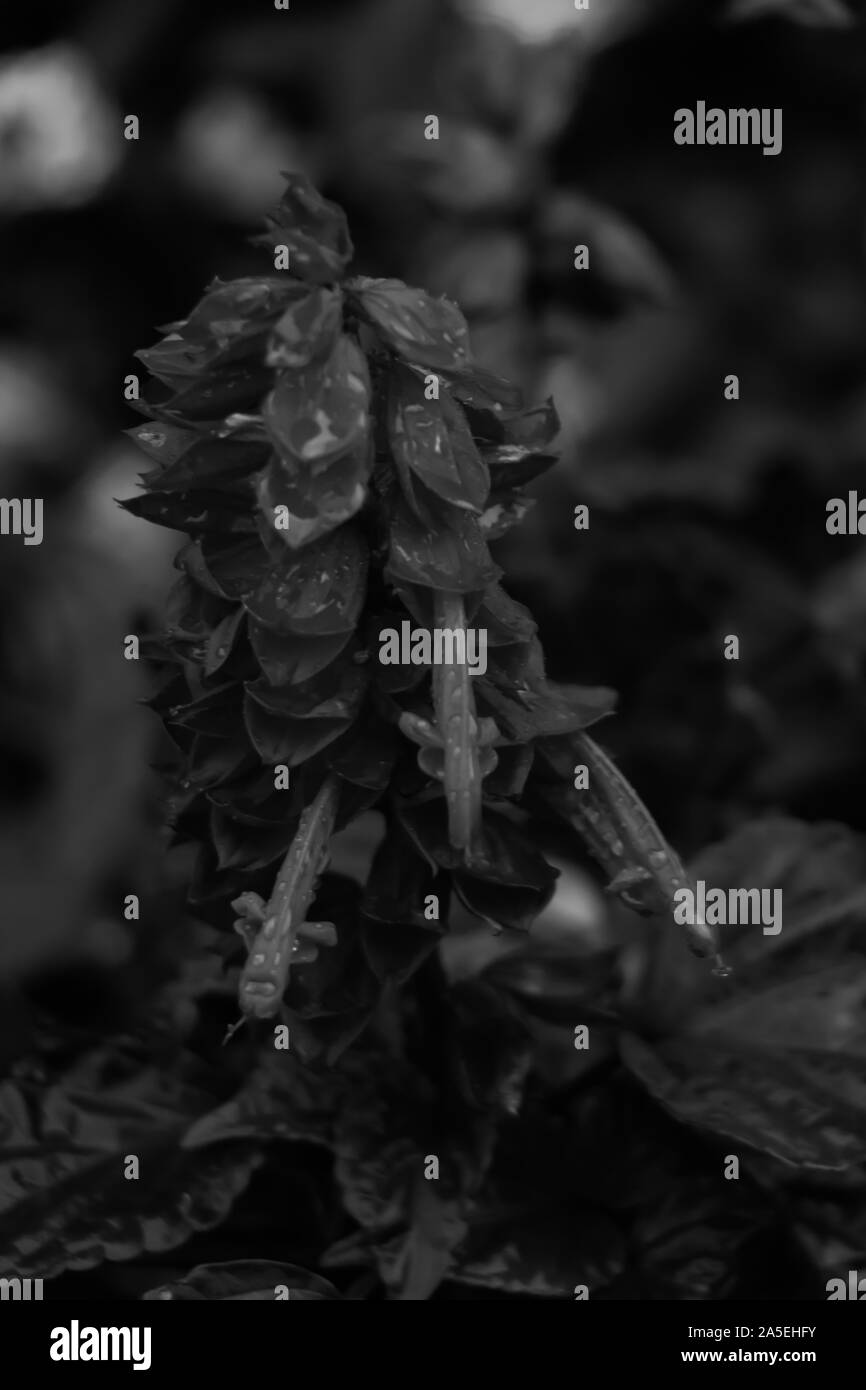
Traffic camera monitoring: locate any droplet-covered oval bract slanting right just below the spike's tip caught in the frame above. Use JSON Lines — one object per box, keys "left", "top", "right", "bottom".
{"left": 346, "top": 277, "right": 470, "bottom": 371}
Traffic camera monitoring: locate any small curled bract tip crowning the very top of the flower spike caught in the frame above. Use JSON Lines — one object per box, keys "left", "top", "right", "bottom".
{"left": 254, "top": 174, "right": 354, "bottom": 285}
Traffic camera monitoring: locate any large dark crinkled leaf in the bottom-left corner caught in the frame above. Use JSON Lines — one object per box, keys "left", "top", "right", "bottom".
{"left": 0, "top": 1034, "right": 271, "bottom": 1279}
